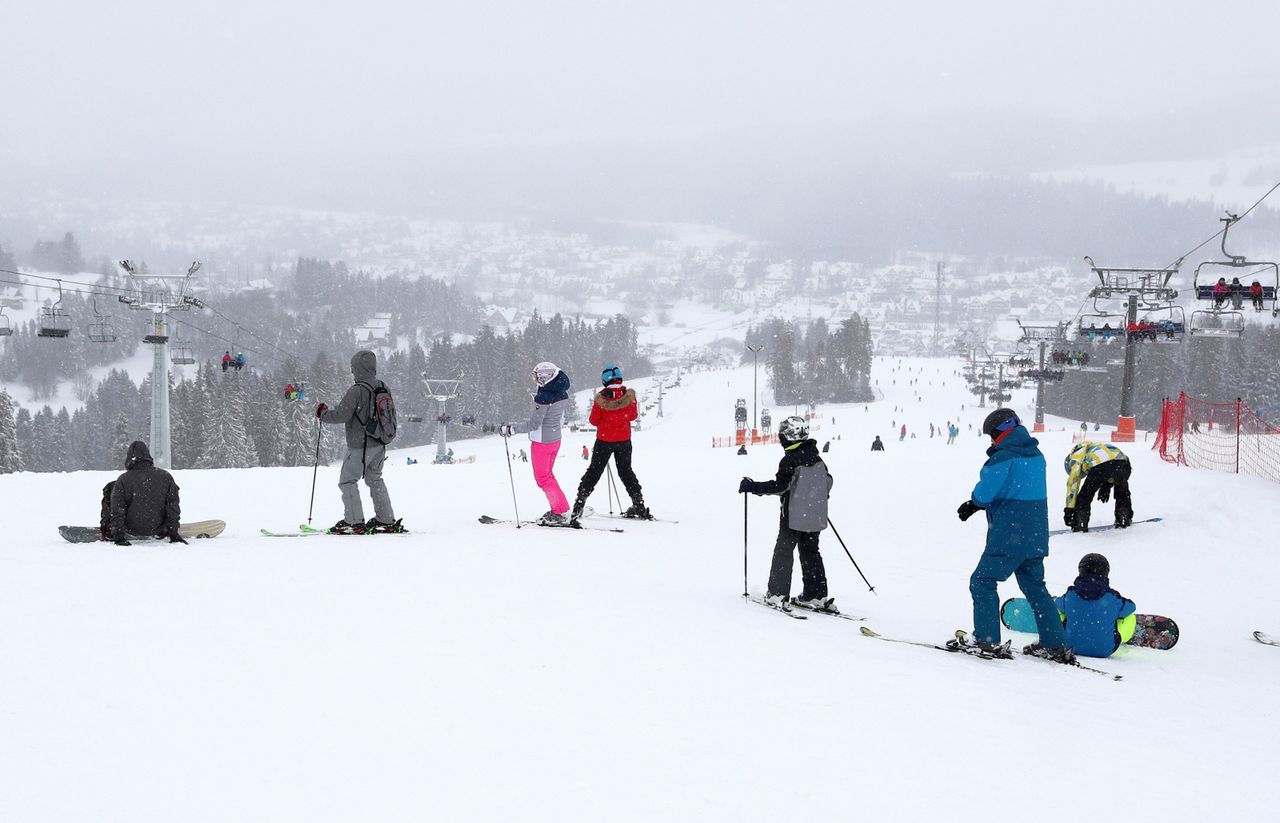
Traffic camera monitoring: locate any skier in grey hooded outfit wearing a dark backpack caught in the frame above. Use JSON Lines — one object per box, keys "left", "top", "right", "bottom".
{"left": 316, "top": 349, "right": 404, "bottom": 534}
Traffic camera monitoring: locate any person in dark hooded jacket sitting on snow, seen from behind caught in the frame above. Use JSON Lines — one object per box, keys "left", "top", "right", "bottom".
{"left": 102, "top": 440, "right": 186, "bottom": 545}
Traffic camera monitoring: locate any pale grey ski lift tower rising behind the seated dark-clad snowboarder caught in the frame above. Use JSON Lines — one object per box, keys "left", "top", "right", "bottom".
{"left": 119, "top": 260, "right": 205, "bottom": 468}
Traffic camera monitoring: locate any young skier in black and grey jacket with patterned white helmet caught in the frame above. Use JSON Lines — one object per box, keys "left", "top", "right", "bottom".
{"left": 737, "top": 416, "right": 834, "bottom": 612}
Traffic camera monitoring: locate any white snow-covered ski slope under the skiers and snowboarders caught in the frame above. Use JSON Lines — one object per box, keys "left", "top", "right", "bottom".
{"left": 0, "top": 360, "right": 1280, "bottom": 823}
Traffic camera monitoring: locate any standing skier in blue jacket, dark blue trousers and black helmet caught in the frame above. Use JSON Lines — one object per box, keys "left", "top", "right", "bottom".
{"left": 956, "top": 408, "right": 1075, "bottom": 663}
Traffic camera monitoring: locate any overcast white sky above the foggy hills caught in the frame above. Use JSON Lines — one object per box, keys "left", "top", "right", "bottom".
{"left": 0, "top": 0, "right": 1280, "bottom": 207}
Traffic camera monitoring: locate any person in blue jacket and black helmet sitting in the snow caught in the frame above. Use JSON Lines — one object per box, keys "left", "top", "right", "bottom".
{"left": 1056, "top": 554, "right": 1138, "bottom": 658}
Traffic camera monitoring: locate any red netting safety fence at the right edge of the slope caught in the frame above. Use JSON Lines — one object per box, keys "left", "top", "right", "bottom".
{"left": 1155, "top": 392, "right": 1280, "bottom": 483}
